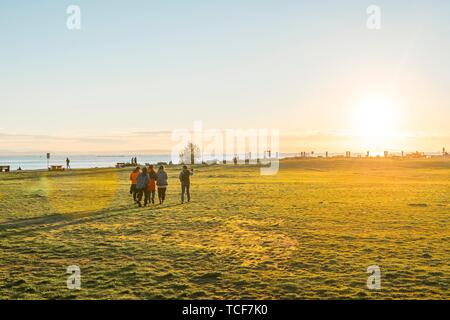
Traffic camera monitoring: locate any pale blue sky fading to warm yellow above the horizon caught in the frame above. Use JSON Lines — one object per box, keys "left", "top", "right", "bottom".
{"left": 0, "top": 0, "right": 450, "bottom": 153}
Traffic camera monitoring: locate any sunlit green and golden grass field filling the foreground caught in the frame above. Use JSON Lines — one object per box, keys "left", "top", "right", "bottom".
{"left": 0, "top": 159, "right": 450, "bottom": 299}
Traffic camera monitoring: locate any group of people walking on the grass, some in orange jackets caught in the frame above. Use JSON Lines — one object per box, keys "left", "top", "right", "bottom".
{"left": 130, "top": 165, "right": 194, "bottom": 207}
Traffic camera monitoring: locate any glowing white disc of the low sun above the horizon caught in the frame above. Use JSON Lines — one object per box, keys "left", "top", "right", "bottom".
{"left": 353, "top": 96, "right": 399, "bottom": 140}
